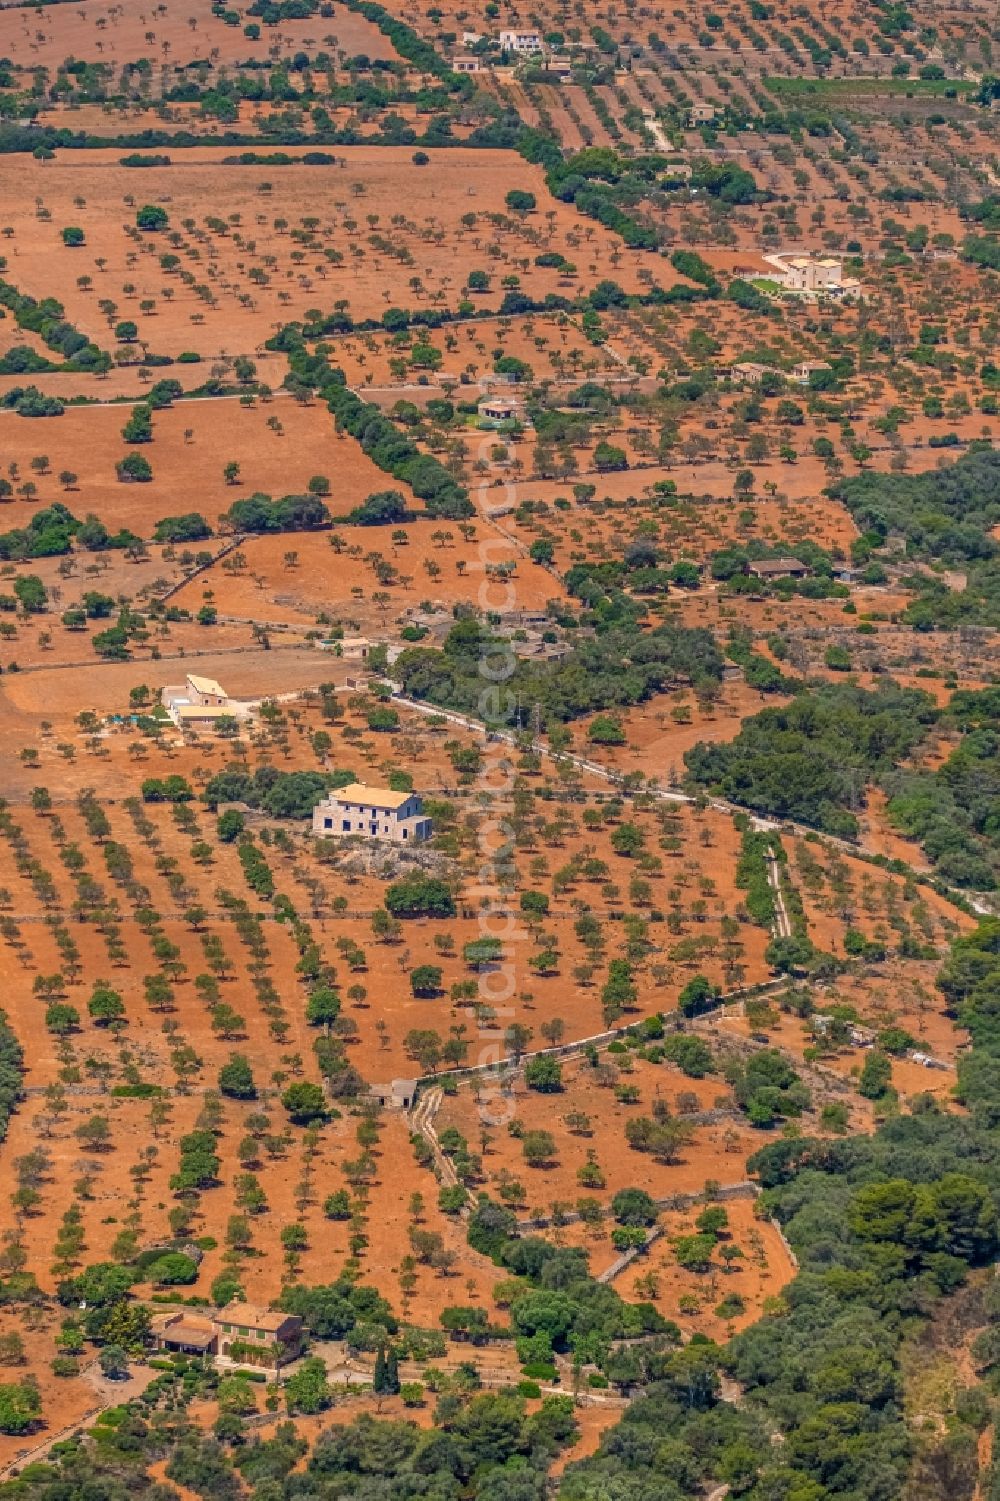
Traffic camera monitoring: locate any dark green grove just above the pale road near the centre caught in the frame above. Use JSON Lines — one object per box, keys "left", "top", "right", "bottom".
{"left": 395, "top": 618, "right": 722, "bottom": 722}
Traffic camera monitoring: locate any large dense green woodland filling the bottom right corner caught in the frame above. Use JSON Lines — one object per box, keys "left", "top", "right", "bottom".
{"left": 560, "top": 919, "right": 1000, "bottom": 1501}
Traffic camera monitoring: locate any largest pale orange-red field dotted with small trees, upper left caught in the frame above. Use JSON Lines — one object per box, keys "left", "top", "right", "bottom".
{"left": 0, "top": 146, "right": 647, "bottom": 357}
